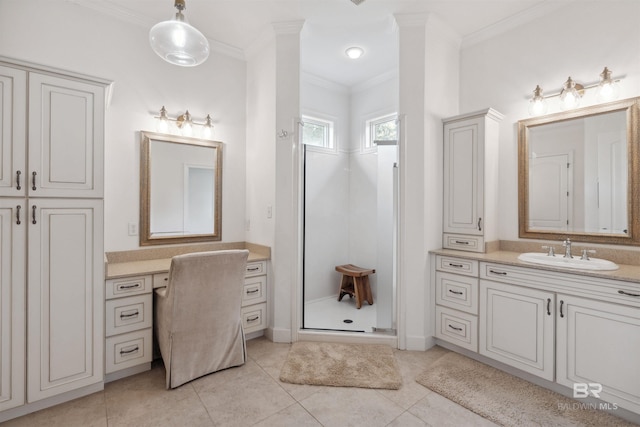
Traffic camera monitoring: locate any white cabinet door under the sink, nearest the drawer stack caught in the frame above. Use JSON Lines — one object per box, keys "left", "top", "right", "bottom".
{"left": 480, "top": 280, "right": 555, "bottom": 381}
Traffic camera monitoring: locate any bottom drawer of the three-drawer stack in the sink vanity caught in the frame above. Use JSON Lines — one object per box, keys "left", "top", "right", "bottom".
{"left": 436, "top": 307, "right": 478, "bottom": 352}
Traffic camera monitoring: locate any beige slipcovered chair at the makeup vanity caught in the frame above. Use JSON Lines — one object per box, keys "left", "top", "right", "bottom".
{"left": 154, "top": 250, "right": 249, "bottom": 389}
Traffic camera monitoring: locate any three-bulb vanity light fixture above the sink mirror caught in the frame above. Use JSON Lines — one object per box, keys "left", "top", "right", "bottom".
{"left": 529, "top": 67, "right": 620, "bottom": 116}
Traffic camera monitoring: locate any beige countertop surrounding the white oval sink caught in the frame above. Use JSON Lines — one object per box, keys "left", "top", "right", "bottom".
{"left": 430, "top": 249, "right": 640, "bottom": 284}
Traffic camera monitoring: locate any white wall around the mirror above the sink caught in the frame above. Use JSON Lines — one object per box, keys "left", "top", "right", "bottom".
{"left": 460, "top": 0, "right": 640, "bottom": 246}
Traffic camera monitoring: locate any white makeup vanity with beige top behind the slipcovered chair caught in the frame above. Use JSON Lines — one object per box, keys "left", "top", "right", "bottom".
{"left": 105, "top": 243, "right": 270, "bottom": 382}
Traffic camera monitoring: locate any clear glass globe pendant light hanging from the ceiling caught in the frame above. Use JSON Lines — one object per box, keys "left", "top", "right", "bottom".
{"left": 149, "top": 0, "right": 209, "bottom": 67}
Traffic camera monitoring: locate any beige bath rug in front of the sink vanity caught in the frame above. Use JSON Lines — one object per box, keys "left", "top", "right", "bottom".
{"left": 416, "top": 352, "right": 635, "bottom": 427}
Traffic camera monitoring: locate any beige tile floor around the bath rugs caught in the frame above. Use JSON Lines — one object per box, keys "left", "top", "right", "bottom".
{"left": 3, "top": 338, "right": 495, "bottom": 427}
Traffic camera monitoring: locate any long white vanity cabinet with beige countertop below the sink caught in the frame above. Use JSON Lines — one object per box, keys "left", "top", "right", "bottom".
{"left": 431, "top": 249, "right": 640, "bottom": 420}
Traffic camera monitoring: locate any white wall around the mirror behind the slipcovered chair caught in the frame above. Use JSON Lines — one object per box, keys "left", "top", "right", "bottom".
{"left": 0, "top": 0, "right": 246, "bottom": 251}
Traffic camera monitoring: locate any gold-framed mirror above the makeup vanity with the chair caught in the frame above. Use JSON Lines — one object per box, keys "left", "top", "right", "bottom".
{"left": 140, "top": 132, "right": 223, "bottom": 246}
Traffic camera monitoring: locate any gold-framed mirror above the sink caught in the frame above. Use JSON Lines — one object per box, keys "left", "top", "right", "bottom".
{"left": 518, "top": 98, "right": 640, "bottom": 245}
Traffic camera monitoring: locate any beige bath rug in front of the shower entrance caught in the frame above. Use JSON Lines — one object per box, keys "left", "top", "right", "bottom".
{"left": 280, "top": 342, "right": 402, "bottom": 390}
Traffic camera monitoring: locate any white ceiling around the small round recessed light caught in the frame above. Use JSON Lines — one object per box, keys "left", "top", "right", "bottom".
{"left": 65, "top": 0, "right": 567, "bottom": 87}
